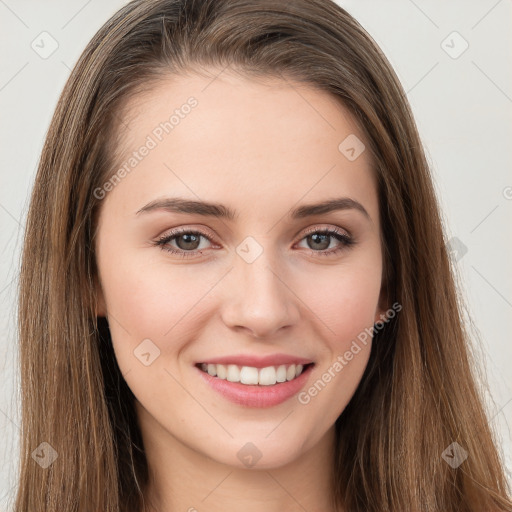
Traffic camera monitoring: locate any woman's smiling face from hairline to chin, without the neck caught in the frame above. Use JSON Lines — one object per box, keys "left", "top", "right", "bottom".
{"left": 95, "top": 71, "right": 383, "bottom": 468}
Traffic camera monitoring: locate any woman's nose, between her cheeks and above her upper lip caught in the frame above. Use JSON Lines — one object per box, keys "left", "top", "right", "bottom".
{"left": 222, "top": 251, "right": 300, "bottom": 338}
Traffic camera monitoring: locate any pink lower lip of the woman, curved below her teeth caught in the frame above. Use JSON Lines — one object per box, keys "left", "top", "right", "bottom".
{"left": 195, "top": 364, "right": 314, "bottom": 407}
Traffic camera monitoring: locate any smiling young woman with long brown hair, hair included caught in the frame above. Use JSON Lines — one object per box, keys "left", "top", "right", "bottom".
{"left": 14, "top": 0, "right": 512, "bottom": 512}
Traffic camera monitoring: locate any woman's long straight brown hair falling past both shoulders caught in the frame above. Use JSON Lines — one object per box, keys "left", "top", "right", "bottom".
{"left": 14, "top": 0, "right": 512, "bottom": 512}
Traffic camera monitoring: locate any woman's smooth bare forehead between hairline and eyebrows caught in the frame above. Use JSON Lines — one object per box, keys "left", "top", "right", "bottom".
{"left": 106, "top": 71, "right": 376, "bottom": 223}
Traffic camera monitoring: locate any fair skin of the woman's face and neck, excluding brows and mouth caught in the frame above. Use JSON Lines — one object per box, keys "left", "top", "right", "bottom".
{"left": 96, "top": 70, "right": 385, "bottom": 512}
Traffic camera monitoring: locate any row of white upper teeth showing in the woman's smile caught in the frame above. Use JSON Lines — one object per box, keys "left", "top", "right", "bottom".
{"left": 201, "top": 363, "right": 304, "bottom": 386}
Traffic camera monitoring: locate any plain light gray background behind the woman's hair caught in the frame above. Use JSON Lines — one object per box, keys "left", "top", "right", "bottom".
{"left": 0, "top": 0, "right": 512, "bottom": 510}
